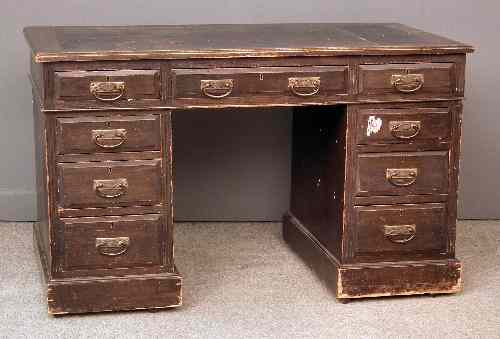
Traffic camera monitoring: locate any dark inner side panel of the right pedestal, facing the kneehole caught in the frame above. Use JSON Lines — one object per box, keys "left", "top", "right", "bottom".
{"left": 290, "top": 106, "right": 346, "bottom": 256}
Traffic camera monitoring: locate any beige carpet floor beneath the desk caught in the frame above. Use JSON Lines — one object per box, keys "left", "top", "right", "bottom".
{"left": 0, "top": 221, "right": 500, "bottom": 338}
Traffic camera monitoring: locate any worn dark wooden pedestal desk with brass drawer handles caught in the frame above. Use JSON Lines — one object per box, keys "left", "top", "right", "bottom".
{"left": 25, "top": 23, "right": 472, "bottom": 314}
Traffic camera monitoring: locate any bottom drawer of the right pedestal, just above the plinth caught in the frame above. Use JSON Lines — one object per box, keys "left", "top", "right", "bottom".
{"left": 353, "top": 204, "right": 448, "bottom": 261}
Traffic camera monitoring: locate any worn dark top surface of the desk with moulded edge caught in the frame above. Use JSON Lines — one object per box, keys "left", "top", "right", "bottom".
{"left": 24, "top": 23, "right": 473, "bottom": 62}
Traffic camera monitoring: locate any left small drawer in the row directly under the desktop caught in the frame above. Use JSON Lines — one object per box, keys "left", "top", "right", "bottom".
{"left": 43, "top": 61, "right": 166, "bottom": 110}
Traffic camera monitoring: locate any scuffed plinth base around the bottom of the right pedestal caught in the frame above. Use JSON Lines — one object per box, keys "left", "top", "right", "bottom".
{"left": 283, "top": 213, "right": 463, "bottom": 300}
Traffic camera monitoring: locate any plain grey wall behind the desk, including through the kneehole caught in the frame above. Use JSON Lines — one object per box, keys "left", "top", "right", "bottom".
{"left": 0, "top": 0, "right": 500, "bottom": 220}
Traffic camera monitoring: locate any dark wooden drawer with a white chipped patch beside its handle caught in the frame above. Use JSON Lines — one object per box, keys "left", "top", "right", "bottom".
{"left": 356, "top": 108, "right": 451, "bottom": 145}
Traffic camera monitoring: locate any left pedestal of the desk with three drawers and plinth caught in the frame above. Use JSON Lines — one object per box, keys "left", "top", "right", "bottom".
{"left": 33, "top": 95, "right": 182, "bottom": 315}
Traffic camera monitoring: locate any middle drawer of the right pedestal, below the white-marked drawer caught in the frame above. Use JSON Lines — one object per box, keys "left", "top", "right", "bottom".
{"left": 356, "top": 151, "right": 449, "bottom": 196}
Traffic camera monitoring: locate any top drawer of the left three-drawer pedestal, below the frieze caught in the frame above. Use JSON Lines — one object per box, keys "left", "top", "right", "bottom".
{"left": 56, "top": 114, "right": 161, "bottom": 154}
